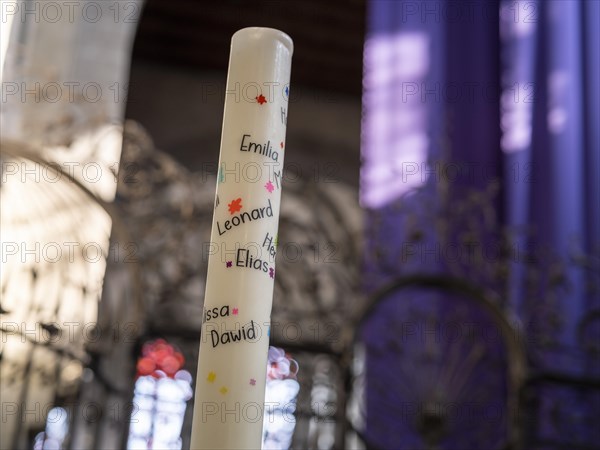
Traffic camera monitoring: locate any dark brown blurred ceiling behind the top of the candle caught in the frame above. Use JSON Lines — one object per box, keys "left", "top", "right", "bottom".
{"left": 133, "top": 0, "right": 365, "bottom": 96}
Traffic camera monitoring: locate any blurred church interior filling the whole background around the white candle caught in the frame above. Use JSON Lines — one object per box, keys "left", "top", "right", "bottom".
{"left": 0, "top": 0, "right": 600, "bottom": 450}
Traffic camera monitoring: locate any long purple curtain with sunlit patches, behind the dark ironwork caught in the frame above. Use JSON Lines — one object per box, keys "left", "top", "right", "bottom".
{"left": 361, "top": 0, "right": 600, "bottom": 448}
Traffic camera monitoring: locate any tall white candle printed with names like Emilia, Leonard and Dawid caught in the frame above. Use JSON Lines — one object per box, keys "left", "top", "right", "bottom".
{"left": 191, "top": 28, "right": 293, "bottom": 449}
